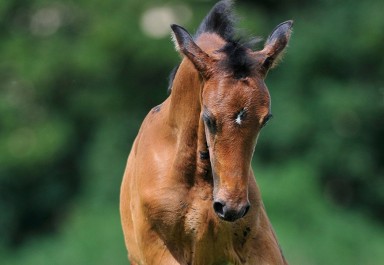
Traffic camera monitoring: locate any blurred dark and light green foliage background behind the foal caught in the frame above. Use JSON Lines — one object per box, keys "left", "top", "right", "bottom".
{"left": 0, "top": 0, "right": 384, "bottom": 265}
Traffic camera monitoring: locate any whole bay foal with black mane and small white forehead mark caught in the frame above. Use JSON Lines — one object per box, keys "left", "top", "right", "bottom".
{"left": 120, "top": 1, "right": 292, "bottom": 265}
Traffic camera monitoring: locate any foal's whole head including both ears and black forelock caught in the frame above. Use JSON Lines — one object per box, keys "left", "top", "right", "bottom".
{"left": 171, "top": 21, "right": 292, "bottom": 221}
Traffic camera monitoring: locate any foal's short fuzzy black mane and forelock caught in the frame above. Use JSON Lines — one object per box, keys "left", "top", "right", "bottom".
{"left": 168, "top": 0, "right": 260, "bottom": 92}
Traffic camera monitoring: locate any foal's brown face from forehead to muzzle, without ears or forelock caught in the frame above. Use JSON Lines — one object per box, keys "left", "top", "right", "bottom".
{"left": 201, "top": 76, "right": 271, "bottom": 221}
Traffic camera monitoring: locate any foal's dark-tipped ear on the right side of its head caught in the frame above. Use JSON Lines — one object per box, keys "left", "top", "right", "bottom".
{"left": 261, "top": 20, "right": 293, "bottom": 73}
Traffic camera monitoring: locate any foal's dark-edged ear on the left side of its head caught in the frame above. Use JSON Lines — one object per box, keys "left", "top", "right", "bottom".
{"left": 171, "top": 24, "right": 212, "bottom": 78}
